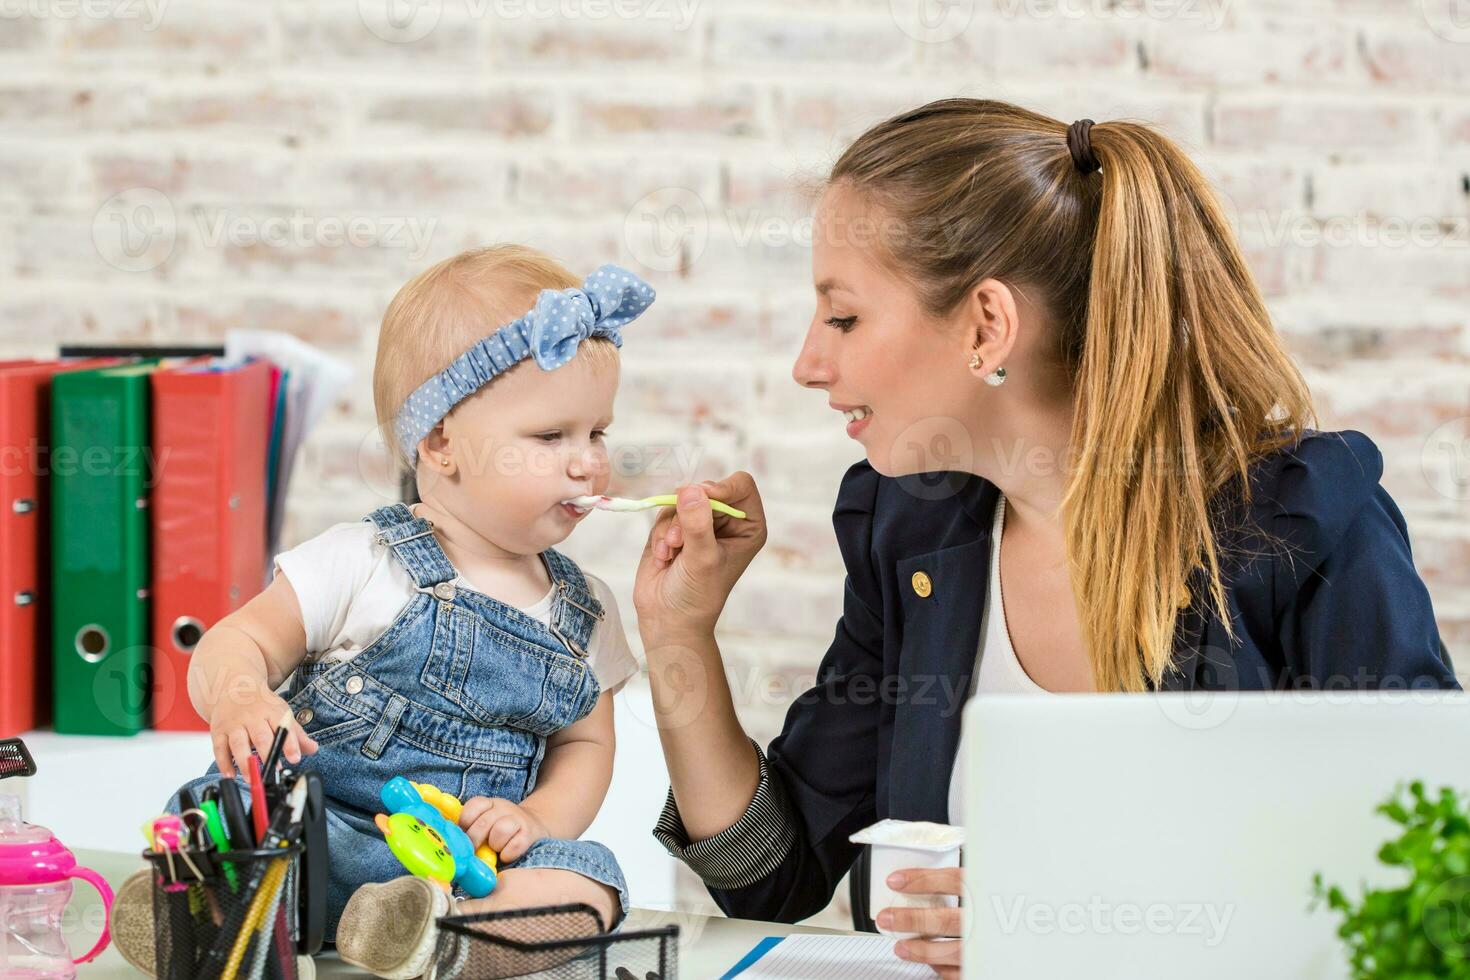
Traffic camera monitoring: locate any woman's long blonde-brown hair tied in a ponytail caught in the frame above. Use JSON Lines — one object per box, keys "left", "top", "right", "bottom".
{"left": 829, "top": 98, "right": 1314, "bottom": 691}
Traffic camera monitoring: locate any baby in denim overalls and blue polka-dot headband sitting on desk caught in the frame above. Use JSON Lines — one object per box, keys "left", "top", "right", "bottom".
{"left": 162, "top": 245, "right": 654, "bottom": 977}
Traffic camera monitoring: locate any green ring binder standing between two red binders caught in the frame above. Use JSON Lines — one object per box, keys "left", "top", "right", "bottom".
{"left": 51, "top": 361, "right": 156, "bottom": 735}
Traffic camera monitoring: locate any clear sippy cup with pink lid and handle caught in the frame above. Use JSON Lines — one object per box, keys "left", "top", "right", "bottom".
{"left": 0, "top": 793, "right": 112, "bottom": 980}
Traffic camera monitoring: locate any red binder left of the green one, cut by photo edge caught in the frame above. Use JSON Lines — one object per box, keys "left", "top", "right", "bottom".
{"left": 0, "top": 359, "right": 118, "bottom": 738}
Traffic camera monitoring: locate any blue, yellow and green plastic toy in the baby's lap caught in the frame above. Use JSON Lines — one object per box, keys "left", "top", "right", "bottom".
{"left": 373, "top": 776, "right": 498, "bottom": 898}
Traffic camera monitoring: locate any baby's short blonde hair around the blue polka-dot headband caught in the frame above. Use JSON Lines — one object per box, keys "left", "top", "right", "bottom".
{"left": 372, "top": 245, "right": 617, "bottom": 458}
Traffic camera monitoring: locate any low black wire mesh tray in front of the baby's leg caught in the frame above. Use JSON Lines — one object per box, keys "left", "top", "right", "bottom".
{"left": 425, "top": 905, "right": 679, "bottom": 980}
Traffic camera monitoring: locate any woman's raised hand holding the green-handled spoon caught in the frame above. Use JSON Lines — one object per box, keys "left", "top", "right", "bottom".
{"left": 634, "top": 473, "right": 766, "bottom": 635}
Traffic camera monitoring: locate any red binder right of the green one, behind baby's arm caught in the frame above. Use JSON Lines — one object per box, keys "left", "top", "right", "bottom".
{"left": 151, "top": 359, "right": 272, "bottom": 732}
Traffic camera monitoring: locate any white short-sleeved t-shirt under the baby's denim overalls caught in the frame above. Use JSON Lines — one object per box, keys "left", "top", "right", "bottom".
{"left": 275, "top": 520, "right": 638, "bottom": 692}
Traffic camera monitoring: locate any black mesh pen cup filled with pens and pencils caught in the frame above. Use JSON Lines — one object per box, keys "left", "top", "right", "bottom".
{"left": 143, "top": 845, "right": 303, "bottom": 980}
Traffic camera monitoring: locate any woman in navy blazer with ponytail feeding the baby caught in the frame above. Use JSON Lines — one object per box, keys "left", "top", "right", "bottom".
{"left": 635, "top": 98, "right": 1457, "bottom": 976}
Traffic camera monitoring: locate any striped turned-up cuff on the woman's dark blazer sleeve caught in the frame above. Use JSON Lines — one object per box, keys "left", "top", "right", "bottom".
{"left": 653, "top": 742, "right": 797, "bottom": 890}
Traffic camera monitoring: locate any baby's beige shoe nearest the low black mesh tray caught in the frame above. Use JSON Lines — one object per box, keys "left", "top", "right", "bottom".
{"left": 337, "top": 874, "right": 454, "bottom": 980}
